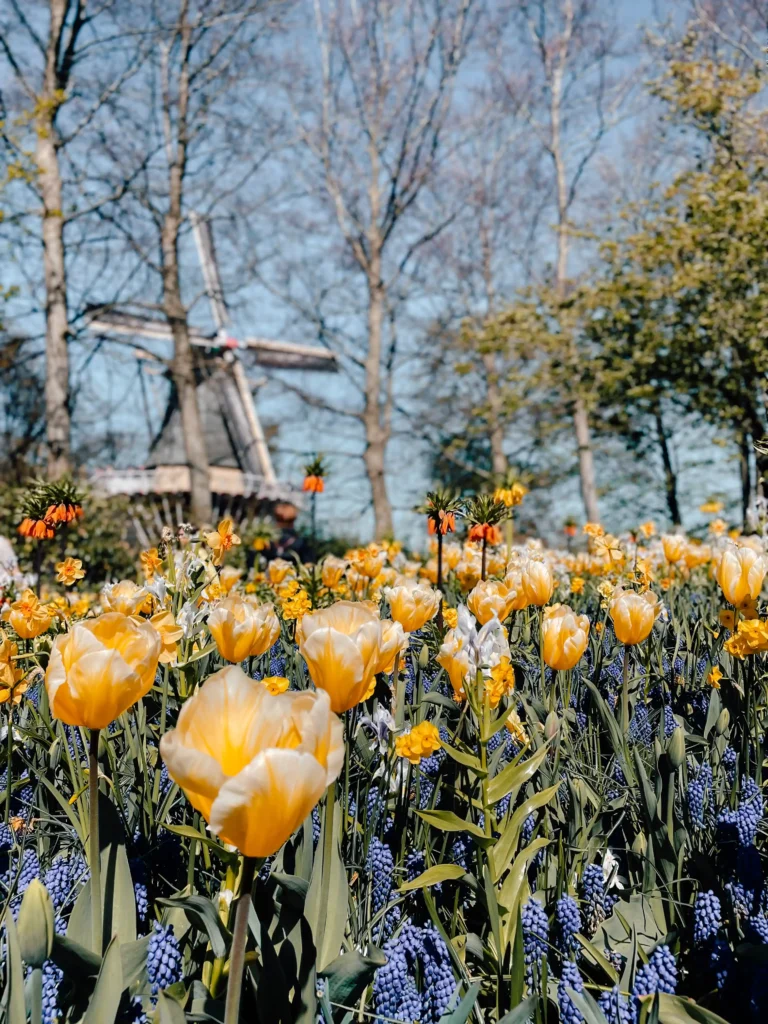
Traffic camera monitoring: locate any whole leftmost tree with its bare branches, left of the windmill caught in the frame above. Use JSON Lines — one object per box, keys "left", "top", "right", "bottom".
{"left": 0, "top": 0, "right": 147, "bottom": 478}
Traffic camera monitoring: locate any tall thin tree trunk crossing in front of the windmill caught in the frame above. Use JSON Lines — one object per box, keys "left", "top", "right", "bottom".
{"left": 161, "top": 9, "right": 211, "bottom": 526}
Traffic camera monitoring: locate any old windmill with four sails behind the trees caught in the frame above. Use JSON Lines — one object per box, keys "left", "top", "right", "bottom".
{"left": 88, "top": 214, "right": 338, "bottom": 543}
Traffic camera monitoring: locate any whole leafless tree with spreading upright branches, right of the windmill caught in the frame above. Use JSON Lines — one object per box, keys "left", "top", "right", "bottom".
{"left": 273, "top": 0, "right": 473, "bottom": 538}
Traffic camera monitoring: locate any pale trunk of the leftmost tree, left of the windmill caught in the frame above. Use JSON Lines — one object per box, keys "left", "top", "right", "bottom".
{"left": 35, "top": 0, "right": 71, "bottom": 479}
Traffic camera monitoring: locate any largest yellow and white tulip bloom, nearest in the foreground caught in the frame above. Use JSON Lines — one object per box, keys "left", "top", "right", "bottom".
{"left": 160, "top": 666, "right": 344, "bottom": 857}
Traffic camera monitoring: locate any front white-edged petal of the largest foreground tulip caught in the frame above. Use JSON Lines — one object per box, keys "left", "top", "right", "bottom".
{"left": 210, "top": 749, "right": 327, "bottom": 857}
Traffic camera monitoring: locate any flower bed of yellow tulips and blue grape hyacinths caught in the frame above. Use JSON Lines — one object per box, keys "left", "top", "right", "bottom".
{"left": 0, "top": 481, "right": 768, "bottom": 1024}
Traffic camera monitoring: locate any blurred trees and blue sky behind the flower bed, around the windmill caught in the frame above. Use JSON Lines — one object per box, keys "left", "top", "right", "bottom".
{"left": 0, "top": 0, "right": 768, "bottom": 536}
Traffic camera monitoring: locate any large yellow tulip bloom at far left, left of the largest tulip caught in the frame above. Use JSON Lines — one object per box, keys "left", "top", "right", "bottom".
{"left": 45, "top": 611, "right": 162, "bottom": 729}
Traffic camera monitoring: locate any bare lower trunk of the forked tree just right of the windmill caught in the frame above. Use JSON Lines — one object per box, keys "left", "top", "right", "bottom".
{"left": 362, "top": 255, "right": 392, "bottom": 541}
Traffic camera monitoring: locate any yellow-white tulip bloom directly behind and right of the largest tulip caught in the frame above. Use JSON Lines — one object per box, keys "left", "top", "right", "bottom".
{"left": 296, "top": 601, "right": 391, "bottom": 714}
